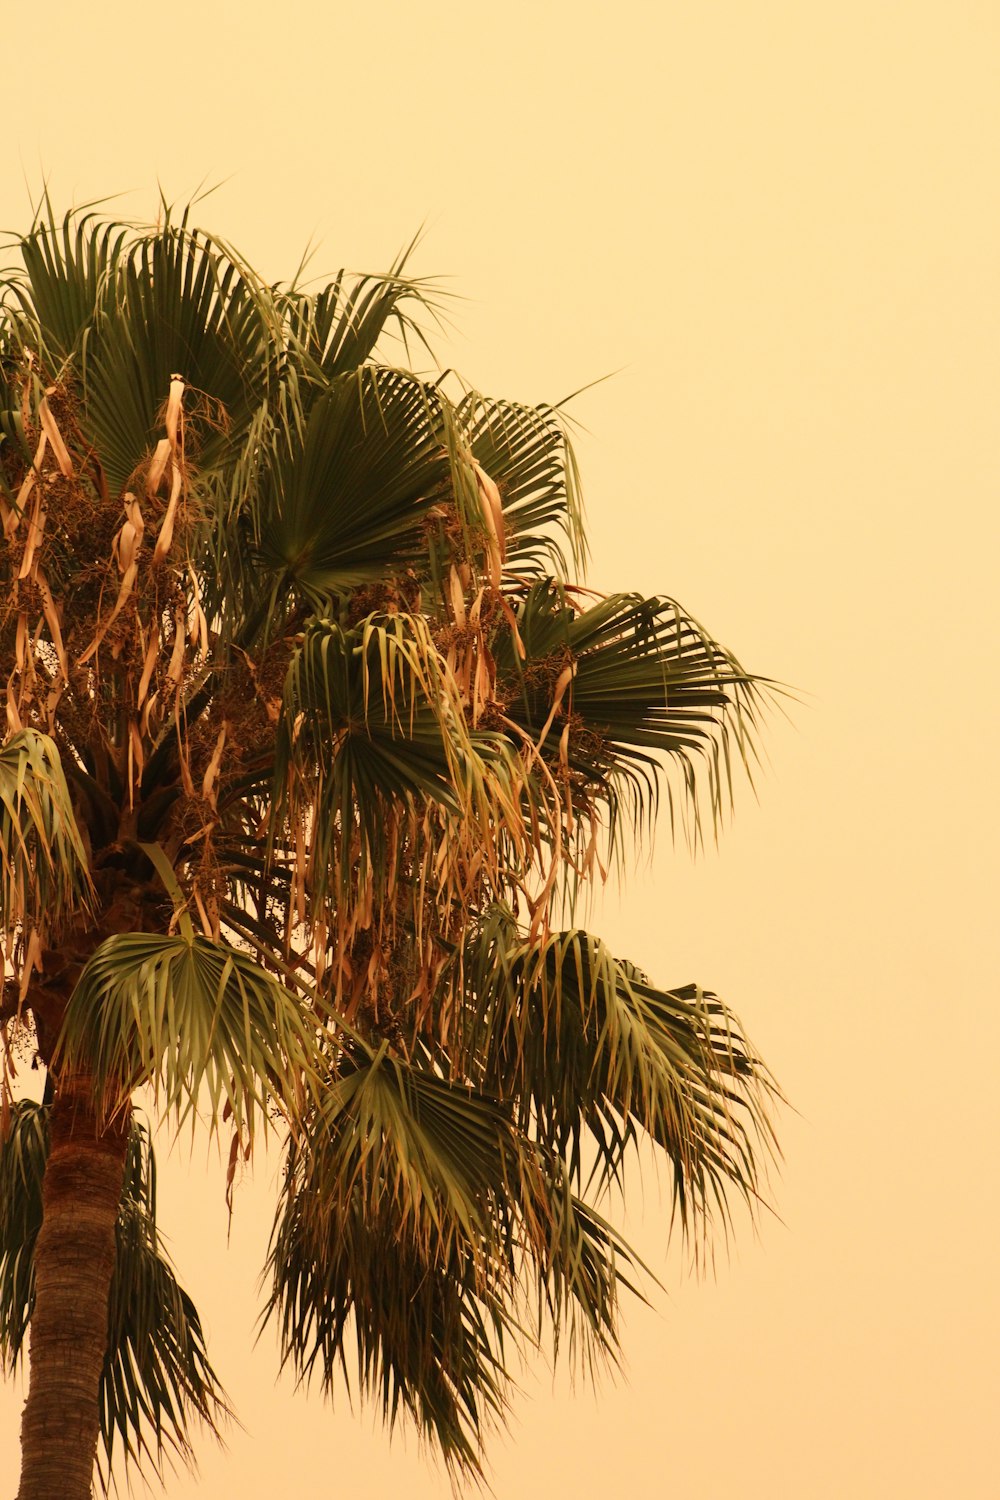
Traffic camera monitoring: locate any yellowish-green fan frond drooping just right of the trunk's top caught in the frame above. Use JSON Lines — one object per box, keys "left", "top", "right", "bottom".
{"left": 55, "top": 927, "right": 315, "bottom": 1136}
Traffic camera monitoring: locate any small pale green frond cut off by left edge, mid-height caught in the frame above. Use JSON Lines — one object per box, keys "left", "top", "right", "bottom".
{"left": 0, "top": 729, "right": 91, "bottom": 933}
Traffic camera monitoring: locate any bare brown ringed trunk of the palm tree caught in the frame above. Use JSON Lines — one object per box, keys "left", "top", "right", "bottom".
{"left": 16, "top": 1074, "right": 127, "bottom": 1500}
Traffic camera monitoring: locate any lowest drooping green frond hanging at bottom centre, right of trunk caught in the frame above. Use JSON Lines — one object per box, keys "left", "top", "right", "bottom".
{"left": 265, "top": 1049, "right": 516, "bottom": 1472}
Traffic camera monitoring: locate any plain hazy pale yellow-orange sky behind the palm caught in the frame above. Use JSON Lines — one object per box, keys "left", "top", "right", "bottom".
{"left": 0, "top": 0, "right": 1000, "bottom": 1500}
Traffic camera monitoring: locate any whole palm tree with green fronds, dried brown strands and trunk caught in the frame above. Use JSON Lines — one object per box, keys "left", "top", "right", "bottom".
{"left": 0, "top": 204, "right": 774, "bottom": 1500}
